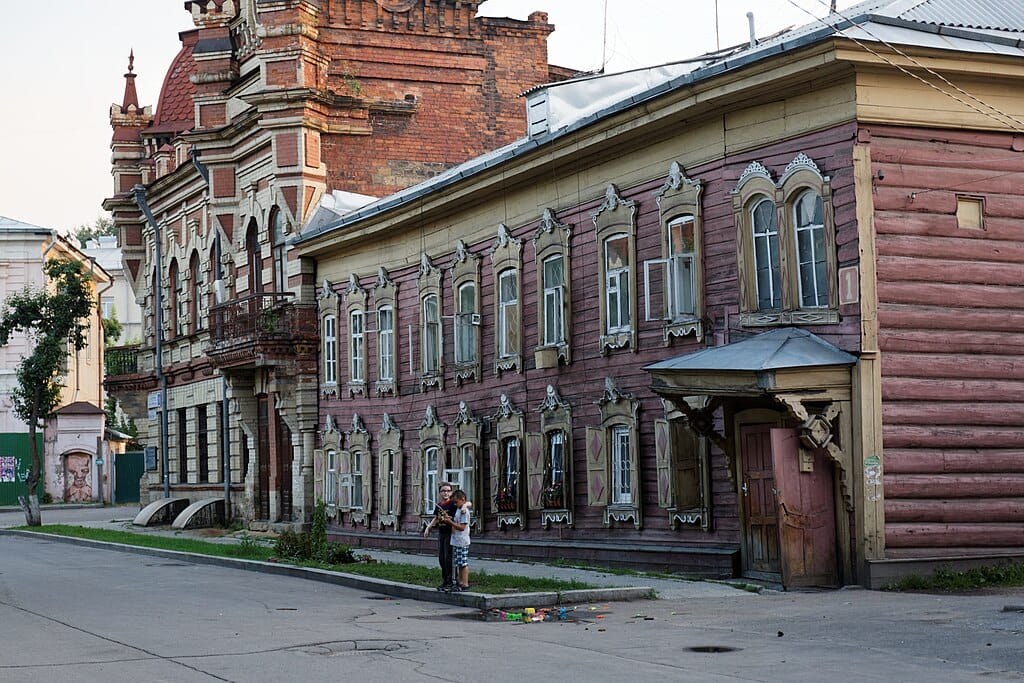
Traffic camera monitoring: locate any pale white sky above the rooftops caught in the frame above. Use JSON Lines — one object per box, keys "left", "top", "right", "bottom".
{"left": 0, "top": 0, "right": 854, "bottom": 229}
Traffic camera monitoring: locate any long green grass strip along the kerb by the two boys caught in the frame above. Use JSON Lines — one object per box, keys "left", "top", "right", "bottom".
{"left": 18, "top": 524, "right": 597, "bottom": 595}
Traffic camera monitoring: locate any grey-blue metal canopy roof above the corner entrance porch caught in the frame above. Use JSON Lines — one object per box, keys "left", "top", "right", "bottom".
{"left": 644, "top": 328, "right": 857, "bottom": 373}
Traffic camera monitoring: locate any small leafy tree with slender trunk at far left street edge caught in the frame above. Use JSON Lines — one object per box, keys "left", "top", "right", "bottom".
{"left": 0, "top": 259, "right": 93, "bottom": 526}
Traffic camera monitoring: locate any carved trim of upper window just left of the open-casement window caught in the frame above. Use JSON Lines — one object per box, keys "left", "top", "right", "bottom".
{"left": 592, "top": 183, "right": 637, "bottom": 355}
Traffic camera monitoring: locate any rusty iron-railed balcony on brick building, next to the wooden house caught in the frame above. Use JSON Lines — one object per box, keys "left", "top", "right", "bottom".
{"left": 206, "top": 293, "right": 318, "bottom": 372}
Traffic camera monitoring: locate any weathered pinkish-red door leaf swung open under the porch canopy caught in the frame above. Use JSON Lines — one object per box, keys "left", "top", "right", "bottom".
{"left": 771, "top": 429, "right": 839, "bottom": 588}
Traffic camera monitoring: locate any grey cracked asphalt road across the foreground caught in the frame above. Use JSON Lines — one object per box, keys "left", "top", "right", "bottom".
{"left": 0, "top": 535, "right": 1024, "bottom": 683}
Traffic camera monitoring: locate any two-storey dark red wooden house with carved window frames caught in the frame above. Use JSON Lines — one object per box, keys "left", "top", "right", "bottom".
{"left": 295, "top": 0, "right": 1024, "bottom": 586}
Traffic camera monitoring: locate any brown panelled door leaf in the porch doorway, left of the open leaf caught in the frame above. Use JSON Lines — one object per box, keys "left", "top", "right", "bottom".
{"left": 739, "top": 424, "right": 782, "bottom": 581}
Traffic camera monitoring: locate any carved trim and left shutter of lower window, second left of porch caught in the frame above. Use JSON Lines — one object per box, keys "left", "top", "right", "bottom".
{"left": 587, "top": 377, "right": 643, "bottom": 529}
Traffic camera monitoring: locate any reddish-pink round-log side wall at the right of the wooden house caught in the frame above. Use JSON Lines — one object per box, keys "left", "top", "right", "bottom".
{"left": 870, "top": 126, "right": 1024, "bottom": 558}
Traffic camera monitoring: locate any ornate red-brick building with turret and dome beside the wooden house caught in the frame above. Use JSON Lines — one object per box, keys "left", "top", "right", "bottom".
{"left": 104, "top": 0, "right": 568, "bottom": 526}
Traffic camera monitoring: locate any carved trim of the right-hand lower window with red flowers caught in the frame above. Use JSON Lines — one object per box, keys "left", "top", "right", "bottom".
{"left": 526, "top": 384, "right": 574, "bottom": 528}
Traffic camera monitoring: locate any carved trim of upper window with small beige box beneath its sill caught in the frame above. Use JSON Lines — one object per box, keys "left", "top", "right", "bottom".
{"left": 534, "top": 209, "right": 572, "bottom": 369}
